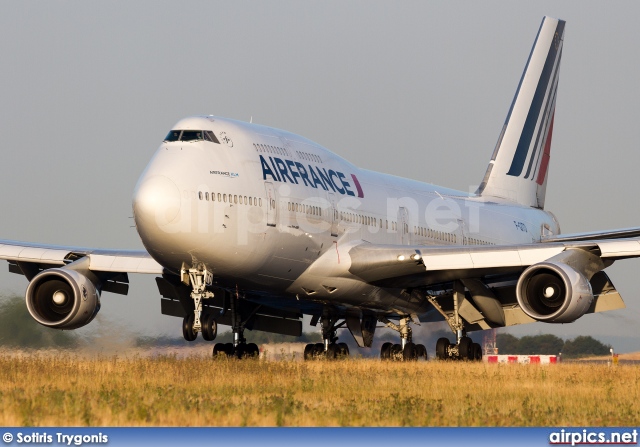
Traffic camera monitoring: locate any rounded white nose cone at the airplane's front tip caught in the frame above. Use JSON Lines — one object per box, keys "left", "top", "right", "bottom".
{"left": 133, "top": 175, "right": 181, "bottom": 231}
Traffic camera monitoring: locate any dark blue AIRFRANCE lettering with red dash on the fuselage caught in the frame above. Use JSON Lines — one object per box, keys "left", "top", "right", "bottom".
{"left": 260, "top": 155, "right": 364, "bottom": 198}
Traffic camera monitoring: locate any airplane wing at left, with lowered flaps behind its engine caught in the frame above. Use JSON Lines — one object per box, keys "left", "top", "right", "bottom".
{"left": 0, "top": 240, "right": 164, "bottom": 295}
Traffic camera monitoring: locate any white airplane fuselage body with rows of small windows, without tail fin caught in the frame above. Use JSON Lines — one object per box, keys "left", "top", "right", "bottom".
{"left": 133, "top": 117, "right": 559, "bottom": 318}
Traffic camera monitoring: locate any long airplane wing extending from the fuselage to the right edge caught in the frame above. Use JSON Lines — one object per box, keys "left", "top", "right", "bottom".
{"left": 349, "top": 237, "right": 640, "bottom": 287}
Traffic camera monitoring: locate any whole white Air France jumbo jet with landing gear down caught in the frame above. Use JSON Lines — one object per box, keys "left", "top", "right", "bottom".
{"left": 0, "top": 18, "right": 640, "bottom": 360}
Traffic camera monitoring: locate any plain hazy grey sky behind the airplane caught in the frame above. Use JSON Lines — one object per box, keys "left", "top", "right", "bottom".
{"left": 0, "top": 0, "right": 640, "bottom": 352}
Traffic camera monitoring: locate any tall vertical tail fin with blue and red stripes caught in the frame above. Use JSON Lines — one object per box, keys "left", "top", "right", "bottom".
{"left": 478, "top": 17, "right": 565, "bottom": 208}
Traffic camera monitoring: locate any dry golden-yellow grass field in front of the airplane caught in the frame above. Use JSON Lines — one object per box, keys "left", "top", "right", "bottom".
{"left": 0, "top": 354, "right": 640, "bottom": 426}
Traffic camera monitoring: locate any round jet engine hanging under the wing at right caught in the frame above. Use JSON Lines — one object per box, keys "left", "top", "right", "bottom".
{"left": 516, "top": 258, "right": 594, "bottom": 323}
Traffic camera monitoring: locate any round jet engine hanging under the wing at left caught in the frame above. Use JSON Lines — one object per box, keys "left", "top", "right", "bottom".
{"left": 26, "top": 268, "right": 100, "bottom": 329}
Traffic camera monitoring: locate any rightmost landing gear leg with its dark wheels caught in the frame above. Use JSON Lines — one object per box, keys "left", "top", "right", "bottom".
{"left": 427, "top": 281, "right": 482, "bottom": 361}
